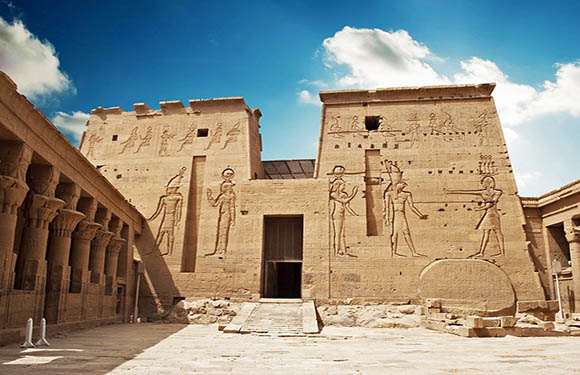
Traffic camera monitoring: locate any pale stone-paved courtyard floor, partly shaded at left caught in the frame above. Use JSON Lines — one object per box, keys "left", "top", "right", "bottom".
{"left": 0, "top": 323, "right": 580, "bottom": 375}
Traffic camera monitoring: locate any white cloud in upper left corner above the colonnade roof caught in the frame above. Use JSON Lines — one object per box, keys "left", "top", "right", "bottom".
{"left": 0, "top": 17, "right": 74, "bottom": 100}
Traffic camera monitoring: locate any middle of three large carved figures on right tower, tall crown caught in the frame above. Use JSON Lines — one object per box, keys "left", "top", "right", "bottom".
{"left": 383, "top": 160, "right": 427, "bottom": 257}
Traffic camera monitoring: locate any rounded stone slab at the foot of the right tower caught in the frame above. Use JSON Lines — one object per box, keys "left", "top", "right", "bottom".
{"left": 419, "top": 259, "right": 516, "bottom": 316}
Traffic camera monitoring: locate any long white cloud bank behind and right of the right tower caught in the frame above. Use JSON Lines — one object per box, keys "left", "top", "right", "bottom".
{"left": 314, "top": 26, "right": 580, "bottom": 129}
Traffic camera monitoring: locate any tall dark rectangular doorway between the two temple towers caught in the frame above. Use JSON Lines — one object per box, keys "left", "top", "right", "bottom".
{"left": 262, "top": 216, "right": 304, "bottom": 298}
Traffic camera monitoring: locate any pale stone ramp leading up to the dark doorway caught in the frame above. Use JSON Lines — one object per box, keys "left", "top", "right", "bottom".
{"left": 224, "top": 300, "right": 319, "bottom": 336}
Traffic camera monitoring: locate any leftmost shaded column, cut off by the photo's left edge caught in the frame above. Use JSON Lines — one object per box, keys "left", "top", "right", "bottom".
{"left": 0, "top": 142, "right": 32, "bottom": 329}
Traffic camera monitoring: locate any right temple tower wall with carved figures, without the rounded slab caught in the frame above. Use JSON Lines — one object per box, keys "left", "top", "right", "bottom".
{"left": 316, "top": 84, "right": 544, "bottom": 300}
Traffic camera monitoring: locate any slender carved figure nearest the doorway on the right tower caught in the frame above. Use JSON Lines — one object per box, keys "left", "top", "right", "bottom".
{"left": 329, "top": 165, "right": 358, "bottom": 257}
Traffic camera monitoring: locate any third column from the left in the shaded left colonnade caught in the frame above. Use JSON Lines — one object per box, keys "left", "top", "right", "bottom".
{"left": 44, "top": 183, "right": 85, "bottom": 323}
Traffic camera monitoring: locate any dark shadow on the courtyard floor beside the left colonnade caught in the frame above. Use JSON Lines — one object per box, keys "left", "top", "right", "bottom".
{"left": 0, "top": 323, "right": 186, "bottom": 375}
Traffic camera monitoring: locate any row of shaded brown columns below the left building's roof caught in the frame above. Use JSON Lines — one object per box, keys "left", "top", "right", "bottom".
{"left": 0, "top": 141, "right": 132, "bottom": 329}
